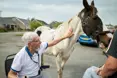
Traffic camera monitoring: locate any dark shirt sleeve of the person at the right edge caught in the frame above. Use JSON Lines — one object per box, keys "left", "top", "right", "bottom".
{"left": 107, "top": 31, "right": 117, "bottom": 58}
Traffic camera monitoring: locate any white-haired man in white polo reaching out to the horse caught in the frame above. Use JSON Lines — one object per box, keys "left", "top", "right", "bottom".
{"left": 8, "top": 28, "right": 73, "bottom": 78}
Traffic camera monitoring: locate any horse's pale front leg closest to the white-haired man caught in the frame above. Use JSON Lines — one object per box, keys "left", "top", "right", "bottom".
{"left": 56, "top": 55, "right": 63, "bottom": 78}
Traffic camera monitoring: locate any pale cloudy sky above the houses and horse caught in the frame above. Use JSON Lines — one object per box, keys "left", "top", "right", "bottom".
{"left": 0, "top": 0, "right": 117, "bottom": 25}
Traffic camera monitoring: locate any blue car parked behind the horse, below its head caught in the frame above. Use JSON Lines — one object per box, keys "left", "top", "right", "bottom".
{"left": 77, "top": 34, "right": 98, "bottom": 47}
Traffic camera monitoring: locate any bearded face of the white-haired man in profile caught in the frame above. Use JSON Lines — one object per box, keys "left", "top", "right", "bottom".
{"left": 31, "top": 36, "right": 41, "bottom": 50}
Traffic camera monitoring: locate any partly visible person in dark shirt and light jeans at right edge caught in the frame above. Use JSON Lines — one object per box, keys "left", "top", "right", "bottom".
{"left": 83, "top": 31, "right": 117, "bottom": 78}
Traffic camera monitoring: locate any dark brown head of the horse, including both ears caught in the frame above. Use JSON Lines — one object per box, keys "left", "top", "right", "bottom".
{"left": 78, "top": 0, "right": 103, "bottom": 39}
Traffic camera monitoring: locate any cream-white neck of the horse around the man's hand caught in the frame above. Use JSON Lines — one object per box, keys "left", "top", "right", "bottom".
{"left": 55, "top": 15, "right": 83, "bottom": 47}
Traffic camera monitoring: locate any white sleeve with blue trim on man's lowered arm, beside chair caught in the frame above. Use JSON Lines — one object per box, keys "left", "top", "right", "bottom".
{"left": 11, "top": 53, "right": 22, "bottom": 72}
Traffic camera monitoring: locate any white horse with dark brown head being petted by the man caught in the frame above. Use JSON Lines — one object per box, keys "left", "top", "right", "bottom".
{"left": 35, "top": 0, "right": 103, "bottom": 78}
